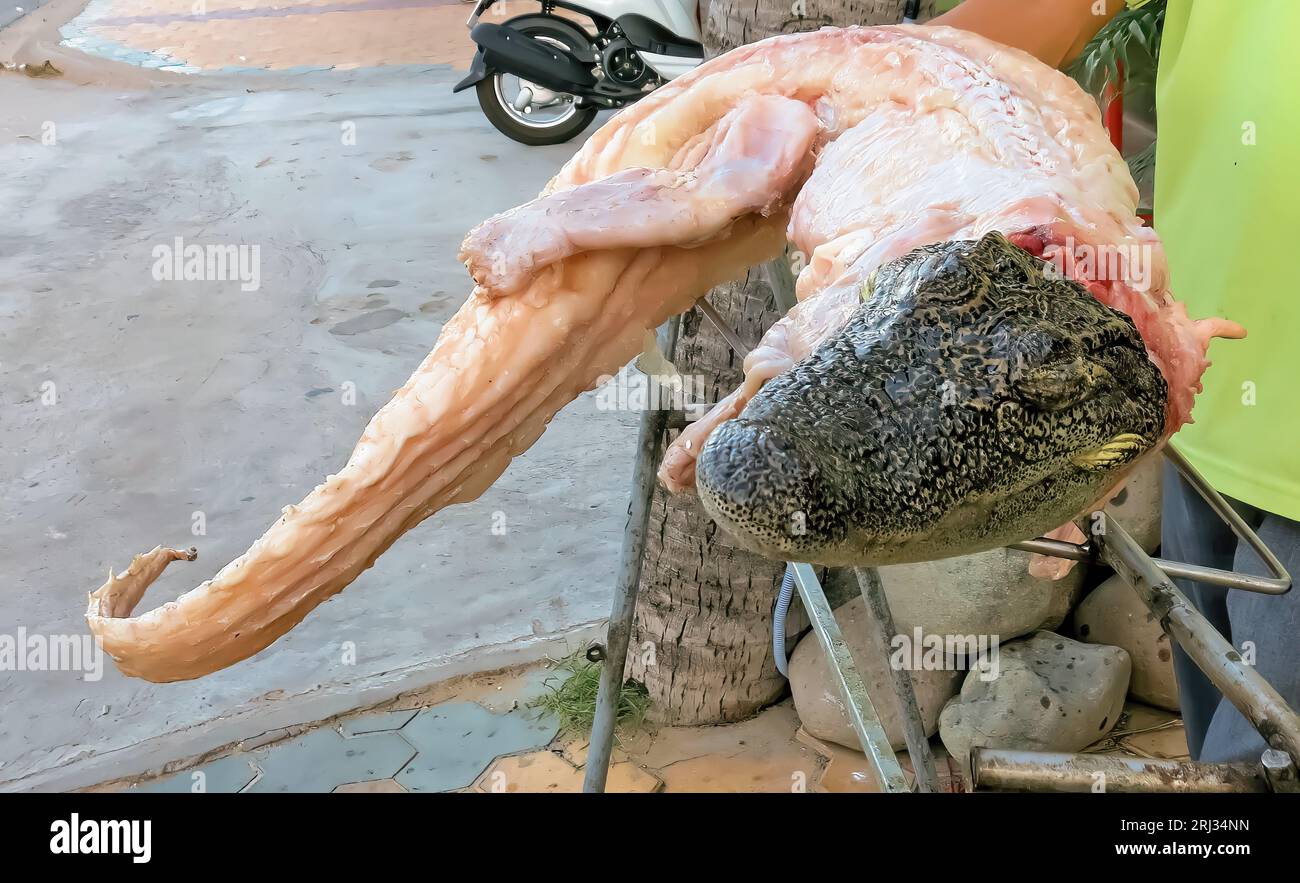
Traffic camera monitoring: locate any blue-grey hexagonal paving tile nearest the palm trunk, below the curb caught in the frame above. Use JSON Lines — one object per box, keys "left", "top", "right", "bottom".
{"left": 394, "top": 702, "right": 559, "bottom": 791}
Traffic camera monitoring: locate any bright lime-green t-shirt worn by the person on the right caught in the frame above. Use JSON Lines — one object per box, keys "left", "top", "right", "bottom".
{"left": 1154, "top": 0, "right": 1300, "bottom": 520}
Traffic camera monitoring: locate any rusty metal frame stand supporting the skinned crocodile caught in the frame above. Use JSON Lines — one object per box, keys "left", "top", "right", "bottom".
{"left": 582, "top": 289, "right": 1300, "bottom": 793}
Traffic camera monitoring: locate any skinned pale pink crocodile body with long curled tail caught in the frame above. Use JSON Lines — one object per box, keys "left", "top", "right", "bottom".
{"left": 87, "top": 27, "right": 1237, "bottom": 681}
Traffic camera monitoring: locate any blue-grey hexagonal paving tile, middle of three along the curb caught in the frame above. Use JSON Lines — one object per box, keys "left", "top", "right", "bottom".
{"left": 248, "top": 727, "right": 415, "bottom": 793}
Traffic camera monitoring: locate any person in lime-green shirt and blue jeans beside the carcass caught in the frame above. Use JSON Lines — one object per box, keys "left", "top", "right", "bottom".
{"left": 931, "top": 0, "right": 1300, "bottom": 762}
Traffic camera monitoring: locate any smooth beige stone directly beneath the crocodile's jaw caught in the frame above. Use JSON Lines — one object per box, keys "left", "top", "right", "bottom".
{"left": 880, "top": 549, "right": 1083, "bottom": 642}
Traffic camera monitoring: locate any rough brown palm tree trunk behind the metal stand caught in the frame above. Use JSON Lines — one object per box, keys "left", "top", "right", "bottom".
{"left": 628, "top": 0, "right": 933, "bottom": 724}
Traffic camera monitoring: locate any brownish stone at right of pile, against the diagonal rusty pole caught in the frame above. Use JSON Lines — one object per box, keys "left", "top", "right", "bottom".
{"left": 1074, "top": 576, "right": 1178, "bottom": 711}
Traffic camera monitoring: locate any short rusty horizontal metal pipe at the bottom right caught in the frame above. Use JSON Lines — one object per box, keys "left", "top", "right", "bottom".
{"left": 971, "top": 748, "right": 1270, "bottom": 793}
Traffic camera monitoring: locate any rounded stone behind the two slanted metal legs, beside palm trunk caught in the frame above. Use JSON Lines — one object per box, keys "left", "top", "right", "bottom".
{"left": 790, "top": 596, "right": 962, "bottom": 750}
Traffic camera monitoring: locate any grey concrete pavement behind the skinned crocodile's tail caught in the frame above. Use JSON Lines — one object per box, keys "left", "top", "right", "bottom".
{"left": 0, "top": 4, "right": 624, "bottom": 789}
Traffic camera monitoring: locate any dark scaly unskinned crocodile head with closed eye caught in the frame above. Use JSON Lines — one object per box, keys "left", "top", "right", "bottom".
{"left": 697, "top": 233, "right": 1167, "bottom": 566}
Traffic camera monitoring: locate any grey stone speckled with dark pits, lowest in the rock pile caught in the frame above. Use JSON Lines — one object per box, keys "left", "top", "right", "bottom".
{"left": 939, "top": 631, "right": 1132, "bottom": 766}
